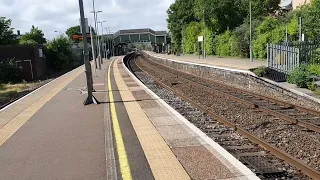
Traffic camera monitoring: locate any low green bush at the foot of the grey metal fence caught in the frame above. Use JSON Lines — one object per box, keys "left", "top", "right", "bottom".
{"left": 287, "top": 66, "right": 311, "bottom": 88}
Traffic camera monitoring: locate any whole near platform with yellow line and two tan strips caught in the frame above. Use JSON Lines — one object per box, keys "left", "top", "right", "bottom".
{"left": 0, "top": 57, "right": 259, "bottom": 180}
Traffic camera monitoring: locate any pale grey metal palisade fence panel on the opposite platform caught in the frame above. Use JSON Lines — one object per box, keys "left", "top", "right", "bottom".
{"left": 267, "top": 44, "right": 300, "bottom": 74}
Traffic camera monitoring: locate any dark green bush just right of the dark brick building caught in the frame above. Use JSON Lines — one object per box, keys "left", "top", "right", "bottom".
{"left": 45, "top": 36, "right": 72, "bottom": 70}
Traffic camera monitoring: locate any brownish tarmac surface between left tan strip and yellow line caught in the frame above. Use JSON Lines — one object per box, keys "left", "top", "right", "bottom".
{"left": 0, "top": 72, "right": 106, "bottom": 180}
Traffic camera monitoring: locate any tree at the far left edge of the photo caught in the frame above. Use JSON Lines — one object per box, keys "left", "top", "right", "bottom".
{"left": 0, "top": 17, "right": 17, "bottom": 45}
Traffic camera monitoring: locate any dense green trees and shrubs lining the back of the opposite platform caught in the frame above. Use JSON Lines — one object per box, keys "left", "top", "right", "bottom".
{"left": 167, "top": 0, "right": 320, "bottom": 59}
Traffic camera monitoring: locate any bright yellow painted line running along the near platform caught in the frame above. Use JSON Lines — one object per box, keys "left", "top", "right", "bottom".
{"left": 108, "top": 61, "right": 132, "bottom": 180}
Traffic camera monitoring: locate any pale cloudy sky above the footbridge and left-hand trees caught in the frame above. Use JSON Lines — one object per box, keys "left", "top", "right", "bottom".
{"left": 0, "top": 0, "right": 175, "bottom": 39}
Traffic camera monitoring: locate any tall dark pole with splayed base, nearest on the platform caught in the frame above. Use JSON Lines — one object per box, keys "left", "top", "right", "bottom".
{"left": 79, "top": 0, "right": 98, "bottom": 105}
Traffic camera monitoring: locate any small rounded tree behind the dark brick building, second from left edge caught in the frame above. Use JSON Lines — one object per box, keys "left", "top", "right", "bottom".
{"left": 20, "top": 25, "right": 47, "bottom": 44}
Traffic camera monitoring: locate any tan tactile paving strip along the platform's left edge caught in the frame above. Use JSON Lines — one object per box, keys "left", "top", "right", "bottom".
{"left": 0, "top": 68, "right": 84, "bottom": 147}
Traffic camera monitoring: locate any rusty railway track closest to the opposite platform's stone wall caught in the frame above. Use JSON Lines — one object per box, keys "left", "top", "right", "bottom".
{"left": 142, "top": 54, "right": 320, "bottom": 133}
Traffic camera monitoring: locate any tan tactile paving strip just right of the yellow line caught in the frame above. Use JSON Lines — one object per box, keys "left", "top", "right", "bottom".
{"left": 113, "top": 59, "right": 190, "bottom": 180}
